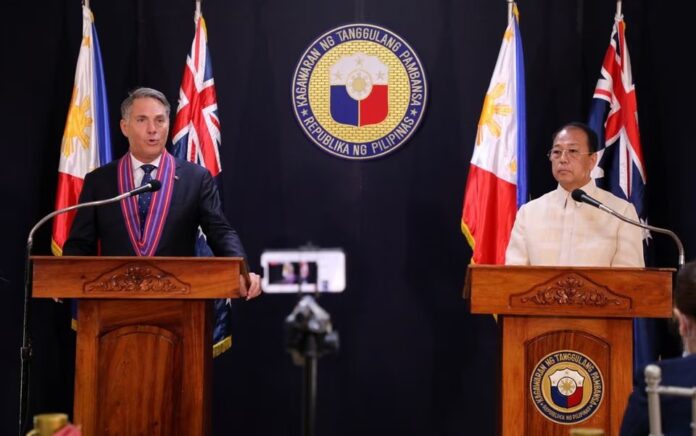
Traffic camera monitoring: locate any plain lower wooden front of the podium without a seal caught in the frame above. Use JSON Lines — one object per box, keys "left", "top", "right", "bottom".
{"left": 74, "top": 300, "right": 212, "bottom": 436}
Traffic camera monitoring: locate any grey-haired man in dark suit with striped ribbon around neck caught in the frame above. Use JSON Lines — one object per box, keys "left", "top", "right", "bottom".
{"left": 63, "top": 88, "right": 261, "bottom": 299}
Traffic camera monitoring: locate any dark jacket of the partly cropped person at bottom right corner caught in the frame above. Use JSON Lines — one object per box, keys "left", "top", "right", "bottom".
{"left": 621, "top": 354, "right": 696, "bottom": 436}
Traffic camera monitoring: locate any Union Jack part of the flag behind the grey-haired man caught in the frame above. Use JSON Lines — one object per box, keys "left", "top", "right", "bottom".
{"left": 172, "top": 16, "right": 222, "bottom": 177}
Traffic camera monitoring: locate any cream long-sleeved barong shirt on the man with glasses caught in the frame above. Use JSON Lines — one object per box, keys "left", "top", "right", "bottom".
{"left": 505, "top": 180, "right": 645, "bottom": 267}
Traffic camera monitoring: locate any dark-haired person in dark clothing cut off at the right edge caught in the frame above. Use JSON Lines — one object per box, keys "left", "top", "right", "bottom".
{"left": 621, "top": 262, "right": 696, "bottom": 436}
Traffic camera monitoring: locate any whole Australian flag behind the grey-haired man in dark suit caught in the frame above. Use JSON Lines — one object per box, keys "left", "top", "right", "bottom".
{"left": 172, "top": 15, "right": 232, "bottom": 356}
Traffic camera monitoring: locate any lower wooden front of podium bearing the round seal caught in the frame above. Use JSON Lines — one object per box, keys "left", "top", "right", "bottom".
{"left": 502, "top": 316, "right": 632, "bottom": 436}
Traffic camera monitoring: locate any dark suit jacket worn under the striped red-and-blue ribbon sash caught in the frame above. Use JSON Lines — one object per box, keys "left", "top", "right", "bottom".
{"left": 63, "top": 159, "right": 245, "bottom": 256}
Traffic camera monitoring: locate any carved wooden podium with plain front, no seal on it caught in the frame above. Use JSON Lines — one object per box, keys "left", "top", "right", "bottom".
{"left": 32, "top": 256, "right": 246, "bottom": 435}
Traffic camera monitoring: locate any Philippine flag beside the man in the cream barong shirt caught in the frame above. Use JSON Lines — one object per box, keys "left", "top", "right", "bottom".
{"left": 461, "top": 2, "right": 527, "bottom": 265}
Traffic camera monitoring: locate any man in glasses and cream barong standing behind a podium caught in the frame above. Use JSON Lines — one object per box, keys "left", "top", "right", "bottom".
{"left": 505, "top": 122, "right": 645, "bottom": 267}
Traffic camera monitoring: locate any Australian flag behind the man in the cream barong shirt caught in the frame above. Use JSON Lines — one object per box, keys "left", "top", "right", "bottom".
{"left": 588, "top": 12, "right": 662, "bottom": 371}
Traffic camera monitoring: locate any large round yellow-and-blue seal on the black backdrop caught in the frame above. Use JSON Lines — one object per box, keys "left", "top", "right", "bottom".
{"left": 292, "top": 24, "right": 427, "bottom": 159}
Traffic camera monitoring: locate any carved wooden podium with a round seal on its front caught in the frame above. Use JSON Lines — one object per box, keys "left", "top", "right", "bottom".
{"left": 464, "top": 265, "right": 674, "bottom": 436}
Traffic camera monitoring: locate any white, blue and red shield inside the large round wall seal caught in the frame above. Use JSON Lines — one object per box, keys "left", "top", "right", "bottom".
{"left": 329, "top": 53, "right": 389, "bottom": 127}
